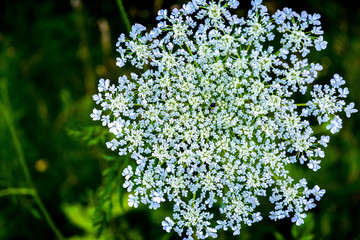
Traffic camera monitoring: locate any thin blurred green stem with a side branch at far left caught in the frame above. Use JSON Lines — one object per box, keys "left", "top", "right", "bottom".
{"left": 0, "top": 102, "right": 65, "bottom": 240}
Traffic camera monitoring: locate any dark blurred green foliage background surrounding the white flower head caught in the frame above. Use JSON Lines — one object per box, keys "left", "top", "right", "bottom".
{"left": 0, "top": 0, "right": 360, "bottom": 240}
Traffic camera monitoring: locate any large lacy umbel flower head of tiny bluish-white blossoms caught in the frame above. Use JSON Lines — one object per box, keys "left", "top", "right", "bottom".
{"left": 91, "top": 0, "right": 357, "bottom": 239}
